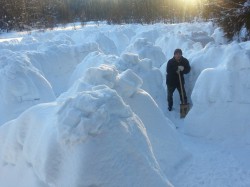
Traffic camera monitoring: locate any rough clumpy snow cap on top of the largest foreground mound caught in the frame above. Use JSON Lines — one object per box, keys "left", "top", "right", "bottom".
{"left": 58, "top": 86, "right": 131, "bottom": 144}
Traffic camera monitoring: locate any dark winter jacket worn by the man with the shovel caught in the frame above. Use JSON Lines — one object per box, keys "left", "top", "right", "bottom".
{"left": 166, "top": 57, "right": 191, "bottom": 86}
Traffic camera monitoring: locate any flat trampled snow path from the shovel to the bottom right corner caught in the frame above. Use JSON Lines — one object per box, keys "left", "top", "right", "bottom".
{"left": 169, "top": 109, "right": 250, "bottom": 187}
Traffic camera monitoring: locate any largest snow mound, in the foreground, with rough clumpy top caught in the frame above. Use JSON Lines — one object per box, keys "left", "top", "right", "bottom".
{"left": 0, "top": 86, "right": 171, "bottom": 187}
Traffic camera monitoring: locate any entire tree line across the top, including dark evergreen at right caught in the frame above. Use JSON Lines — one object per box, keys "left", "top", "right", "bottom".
{"left": 0, "top": 0, "right": 250, "bottom": 39}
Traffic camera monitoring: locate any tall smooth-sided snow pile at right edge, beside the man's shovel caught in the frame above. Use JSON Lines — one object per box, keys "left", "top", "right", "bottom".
{"left": 185, "top": 43, "right": 250, "bottom": 143}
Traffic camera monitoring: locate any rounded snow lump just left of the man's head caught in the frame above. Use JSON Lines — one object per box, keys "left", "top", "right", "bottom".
{"left": 126, "top": 38, "right": 166, "bottom": 68}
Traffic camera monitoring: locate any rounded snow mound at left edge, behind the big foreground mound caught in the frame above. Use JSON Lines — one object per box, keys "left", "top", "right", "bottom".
{"left": 0, "top": 50, "right": 55, "bottom": 124}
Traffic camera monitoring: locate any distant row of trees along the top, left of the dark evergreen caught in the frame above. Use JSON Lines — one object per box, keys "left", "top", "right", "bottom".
{"left": 0, "top": 0, "right": 205, "bottom": 30}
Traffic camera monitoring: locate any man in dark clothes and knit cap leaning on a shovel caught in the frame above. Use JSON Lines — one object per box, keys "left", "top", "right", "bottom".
{"left": 166, "top": 49, "right": 191, "bottom": 111}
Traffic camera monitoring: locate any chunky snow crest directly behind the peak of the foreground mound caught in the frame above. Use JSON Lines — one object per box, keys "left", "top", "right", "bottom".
{"left": 70, "top": 64, "right": 143, "bottom": 99}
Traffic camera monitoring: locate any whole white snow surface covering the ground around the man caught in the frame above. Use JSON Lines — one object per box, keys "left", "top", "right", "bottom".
{"left": 0, "top": 22, "right": 250, "bottom": 187}
